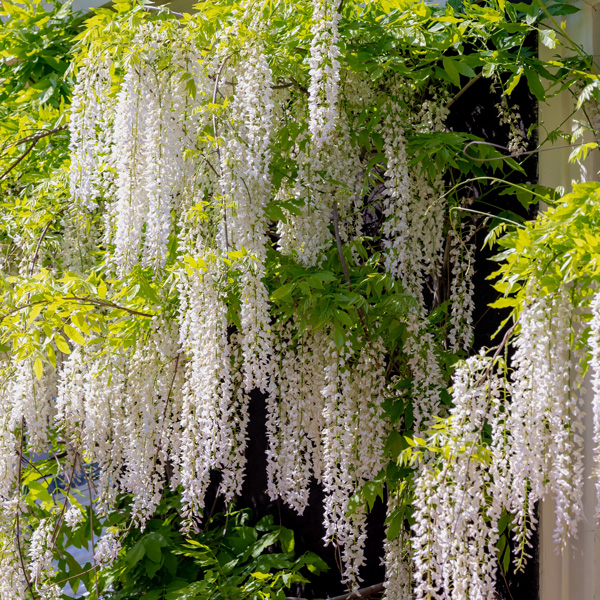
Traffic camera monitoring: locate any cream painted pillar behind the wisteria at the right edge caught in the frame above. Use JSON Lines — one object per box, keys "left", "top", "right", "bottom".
{"left": 539, "top": 0, "right": 600, "bottom": 600}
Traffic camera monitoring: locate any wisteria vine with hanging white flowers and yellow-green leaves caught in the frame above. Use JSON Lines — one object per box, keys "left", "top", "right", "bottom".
{"left": 0, "top": 0, "right": 600, "bottom": 600}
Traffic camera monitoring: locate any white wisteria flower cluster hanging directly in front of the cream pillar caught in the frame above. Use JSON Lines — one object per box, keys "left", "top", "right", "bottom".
{"left": 508, "top": 287, "right": 583, "bottom": 546}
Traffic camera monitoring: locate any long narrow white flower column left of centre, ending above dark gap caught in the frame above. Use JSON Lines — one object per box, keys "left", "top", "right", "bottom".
{"left": 222, "top": 45, "right": 273, "bottom": 392}
